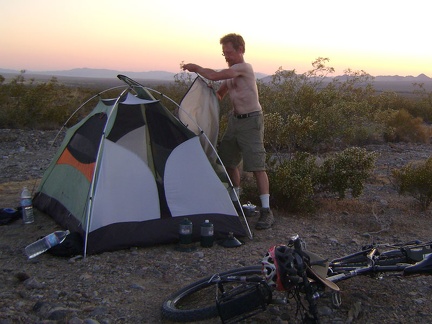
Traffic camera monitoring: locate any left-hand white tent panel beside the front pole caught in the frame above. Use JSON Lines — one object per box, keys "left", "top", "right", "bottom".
{"left": 90, "top": 139, "right": 160, "bottom": 231}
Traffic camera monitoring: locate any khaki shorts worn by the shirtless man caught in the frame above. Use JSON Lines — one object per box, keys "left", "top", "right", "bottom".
{"left": 218, "top": 114, "right": 266, "bottom": 172}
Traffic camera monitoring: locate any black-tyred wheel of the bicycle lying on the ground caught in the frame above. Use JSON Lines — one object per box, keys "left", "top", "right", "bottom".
{"left": 162, "top": 265, "right": 262, "bottom": 322}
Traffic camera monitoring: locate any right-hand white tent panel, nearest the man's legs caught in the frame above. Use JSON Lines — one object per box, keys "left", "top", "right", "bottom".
{"left": 165, "top": 136, "right": 237, "bottom": 216}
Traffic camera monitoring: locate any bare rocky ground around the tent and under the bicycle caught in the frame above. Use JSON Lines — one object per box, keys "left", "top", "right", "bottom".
{"left": 0, "top": 130, "right": 432, "bottom": 324}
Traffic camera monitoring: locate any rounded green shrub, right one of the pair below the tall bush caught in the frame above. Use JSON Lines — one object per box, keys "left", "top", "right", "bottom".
{"left": 319, "top": 147, "right": 376, "bottom": 199}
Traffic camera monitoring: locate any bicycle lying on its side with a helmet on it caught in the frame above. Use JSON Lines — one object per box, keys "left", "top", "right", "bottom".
{"left": 161, "top": 235, "right": 432, "bottom": 323}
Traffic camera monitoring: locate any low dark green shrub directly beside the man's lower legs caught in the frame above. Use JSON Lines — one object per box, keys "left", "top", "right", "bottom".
{"left": 268, "top": 152, "right": 318, "bottom": 211}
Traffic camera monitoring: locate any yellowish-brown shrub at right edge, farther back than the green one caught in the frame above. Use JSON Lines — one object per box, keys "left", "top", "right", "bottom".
{"left": 380, "top": 109, "right": 430, "bottom": 143}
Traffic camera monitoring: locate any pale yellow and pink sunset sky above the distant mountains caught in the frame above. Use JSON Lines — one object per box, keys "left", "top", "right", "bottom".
{"left": 0, "top": 0, "right": 432, "bottom": 77}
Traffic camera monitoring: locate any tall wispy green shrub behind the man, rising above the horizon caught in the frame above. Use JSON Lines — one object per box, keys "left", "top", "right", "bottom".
{"left": 258, "top": 58, "right": 384, "bottom": 152}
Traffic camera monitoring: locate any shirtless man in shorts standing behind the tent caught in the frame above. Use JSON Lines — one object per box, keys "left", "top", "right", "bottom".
{"left": 183, "top": 34, "right": 274, "bottom": 229}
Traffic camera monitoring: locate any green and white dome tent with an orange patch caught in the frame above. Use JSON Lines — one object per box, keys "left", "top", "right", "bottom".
{"left": 34, "top": 76, "right": 251, "bottom": 254}
